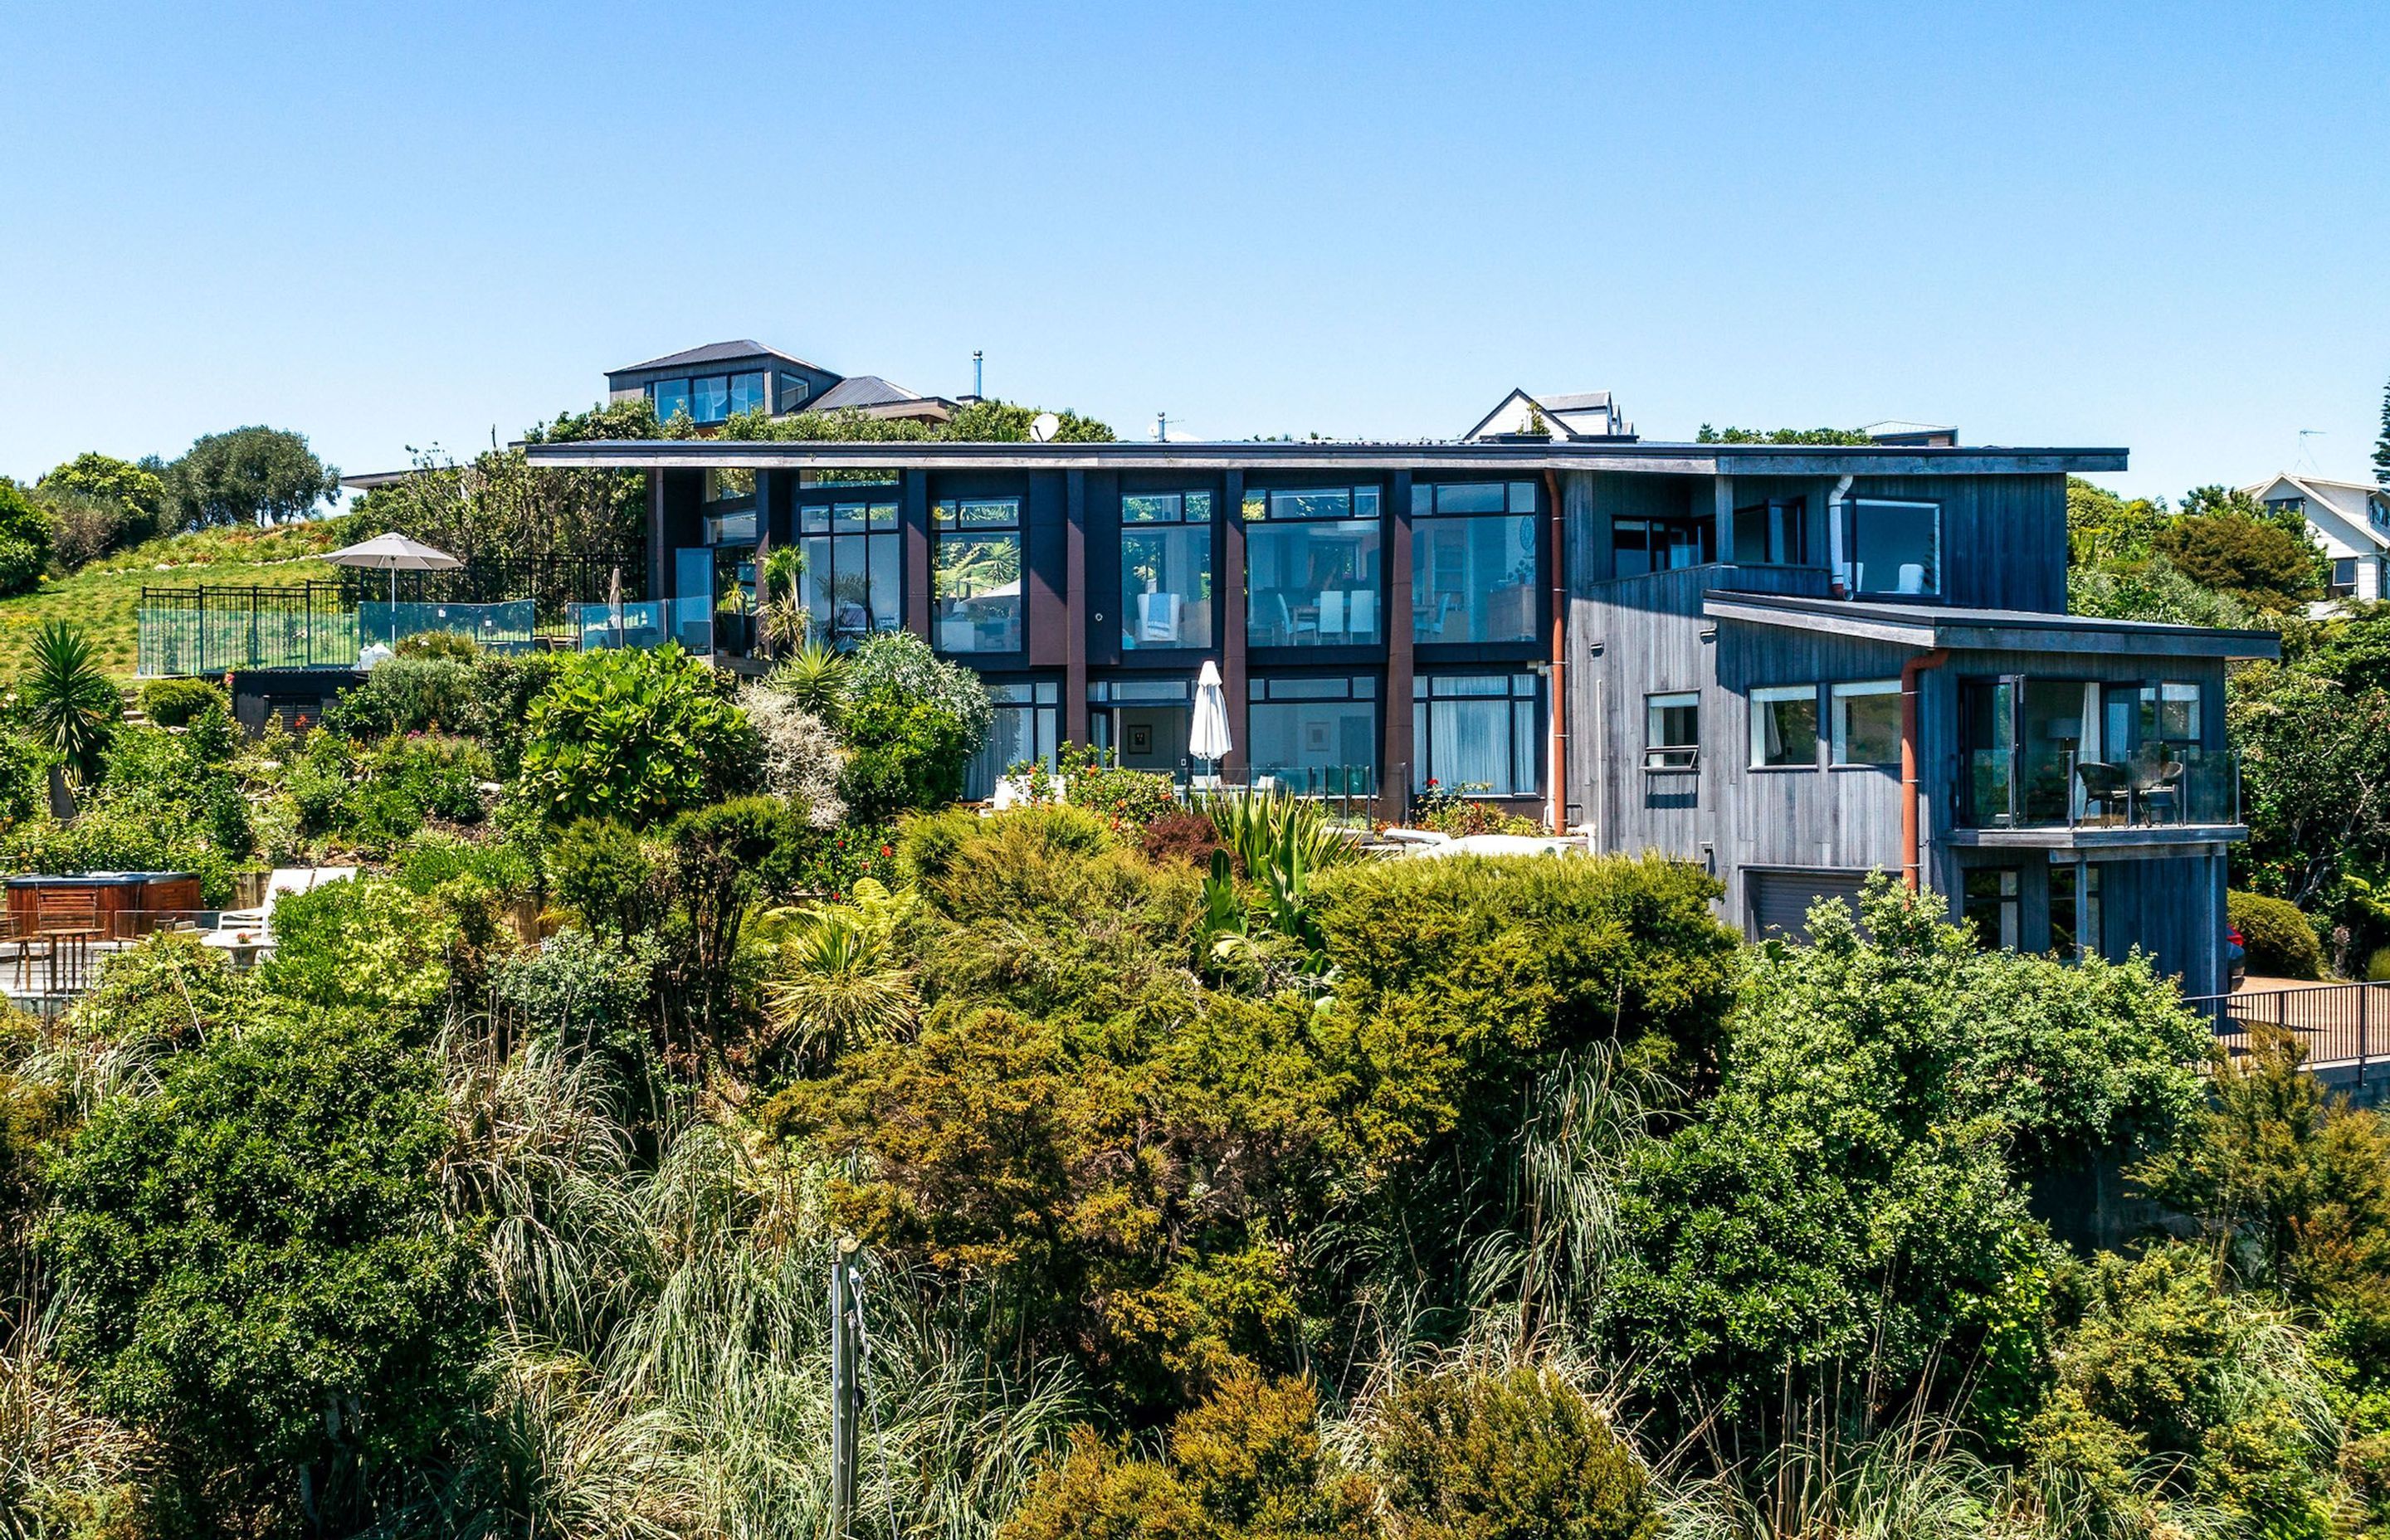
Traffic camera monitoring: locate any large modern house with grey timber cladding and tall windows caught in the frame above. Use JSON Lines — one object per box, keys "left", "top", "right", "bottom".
{"left": 509, "top": 363, "right": 2278, "bottom": 995}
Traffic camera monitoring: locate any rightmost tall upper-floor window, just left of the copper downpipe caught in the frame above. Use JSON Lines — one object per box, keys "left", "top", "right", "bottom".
{"left": 1410, "top": 480, "right": 1537, "bottom": 643}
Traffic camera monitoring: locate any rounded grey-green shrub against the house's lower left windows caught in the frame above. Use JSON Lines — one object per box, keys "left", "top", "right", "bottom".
{"left": 836, "top": 631, "right": 992, "bottom": 822}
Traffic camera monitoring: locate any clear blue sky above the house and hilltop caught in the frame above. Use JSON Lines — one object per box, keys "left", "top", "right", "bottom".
{"left": 0, "top": 0, "right": 2390, "bottom": 495}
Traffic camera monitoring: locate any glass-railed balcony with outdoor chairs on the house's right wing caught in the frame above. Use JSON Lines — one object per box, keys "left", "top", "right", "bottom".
{"left": 1955, "top": 743, "right": 2241, "bottom": 844}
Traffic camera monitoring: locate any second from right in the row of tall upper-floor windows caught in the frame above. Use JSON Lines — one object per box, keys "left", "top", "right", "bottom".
{"left": 1245, "top": 485, "right": 1379, "bottom": 648}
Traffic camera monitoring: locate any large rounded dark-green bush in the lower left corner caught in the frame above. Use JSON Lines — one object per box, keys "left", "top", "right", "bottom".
{"left": 46, "top": 1014, "right": 483, "bottom": 1528}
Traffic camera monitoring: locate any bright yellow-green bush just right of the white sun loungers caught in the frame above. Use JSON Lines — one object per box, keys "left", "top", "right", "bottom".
{"left": 258, "top": 878, "right": 464, "bottom": 1026}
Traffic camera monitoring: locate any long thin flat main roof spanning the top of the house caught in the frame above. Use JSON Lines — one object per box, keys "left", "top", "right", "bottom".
{"left": 524, "top": 437, "right": 2124, "bottom": 476}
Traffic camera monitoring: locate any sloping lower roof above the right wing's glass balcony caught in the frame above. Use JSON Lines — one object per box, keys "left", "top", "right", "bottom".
{"left": 1702, "top": 593, "right": 2282, "bottom": 658}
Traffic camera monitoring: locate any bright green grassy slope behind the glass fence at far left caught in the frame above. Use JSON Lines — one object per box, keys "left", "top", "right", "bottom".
{"left": 0, "top": 514, "right": 361, "bottom": 679}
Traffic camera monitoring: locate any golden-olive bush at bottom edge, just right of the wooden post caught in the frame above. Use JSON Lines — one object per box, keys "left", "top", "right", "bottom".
{"left": 997, "top": 1375, "right": 1377, "bottom": 1540}
